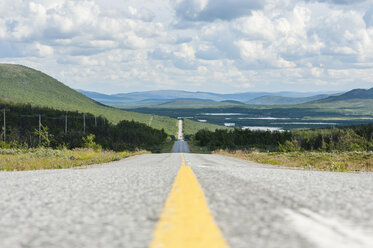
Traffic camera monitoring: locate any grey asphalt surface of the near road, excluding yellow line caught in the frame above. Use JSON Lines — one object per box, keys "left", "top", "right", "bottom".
{"left": 0, "top": 154, "right": 373, "bottom": 248}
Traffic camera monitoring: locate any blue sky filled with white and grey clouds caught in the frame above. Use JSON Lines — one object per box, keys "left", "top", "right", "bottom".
{"left": 0, "top": 0, "right": 373, "bottom": 94}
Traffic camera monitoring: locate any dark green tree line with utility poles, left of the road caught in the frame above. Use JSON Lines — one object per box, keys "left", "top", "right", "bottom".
{"left": 0, "top": 102, "right": 167, "bottom": 152}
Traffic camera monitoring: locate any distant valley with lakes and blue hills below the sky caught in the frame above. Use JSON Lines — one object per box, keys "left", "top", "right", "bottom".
{"left": 82, "top": 88, "right": 373, "bottom": 133}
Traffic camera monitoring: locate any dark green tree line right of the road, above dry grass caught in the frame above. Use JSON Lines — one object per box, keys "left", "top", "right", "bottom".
{"left": 193, "top": 124, "right": 373, "bottom": 152}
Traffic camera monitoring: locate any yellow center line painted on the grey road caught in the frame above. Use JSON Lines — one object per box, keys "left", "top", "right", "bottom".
{"left": 150, "top": 154, "right": 228, "bottom": 248}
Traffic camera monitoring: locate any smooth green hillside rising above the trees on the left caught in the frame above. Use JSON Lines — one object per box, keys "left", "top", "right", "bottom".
{"left": 0, "top": 64, "right": 177, "bottom": 134}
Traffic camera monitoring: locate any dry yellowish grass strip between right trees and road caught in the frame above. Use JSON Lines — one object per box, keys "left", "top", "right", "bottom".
{"left": 212, "top": 150, "right": 373, "bottom": 172}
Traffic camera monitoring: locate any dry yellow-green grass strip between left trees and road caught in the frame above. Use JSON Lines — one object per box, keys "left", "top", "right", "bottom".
{"left": 0, "top": 148, "right": 147, "bottom": 171}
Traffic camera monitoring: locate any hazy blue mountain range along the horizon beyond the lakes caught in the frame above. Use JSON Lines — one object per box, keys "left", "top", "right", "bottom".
{"left": 77, "top": 90, "right": 340, "bottom": 108}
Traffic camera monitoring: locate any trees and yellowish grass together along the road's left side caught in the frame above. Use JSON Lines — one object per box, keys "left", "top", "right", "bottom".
{"left": 0, "top": 101, "right": 172, "bottom": 171}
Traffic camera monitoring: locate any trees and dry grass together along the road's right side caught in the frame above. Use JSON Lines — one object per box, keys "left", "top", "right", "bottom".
{"left": 189, "top": 124, "right": 373, "bottom": 171}
